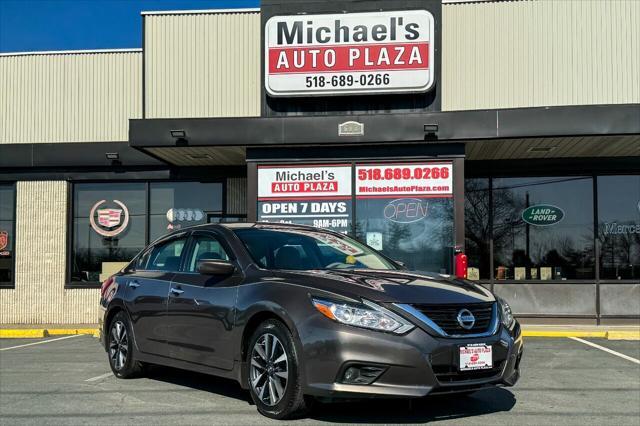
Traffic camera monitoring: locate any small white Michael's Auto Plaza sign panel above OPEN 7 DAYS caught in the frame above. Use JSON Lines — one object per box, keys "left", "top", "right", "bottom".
{"left": 258, "top": 165, "right": 351, "bottom": 199}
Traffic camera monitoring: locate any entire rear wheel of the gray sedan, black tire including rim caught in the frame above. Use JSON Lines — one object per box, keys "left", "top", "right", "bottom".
{"left": 107, "top": 311, "right": 143, "bottom": 379}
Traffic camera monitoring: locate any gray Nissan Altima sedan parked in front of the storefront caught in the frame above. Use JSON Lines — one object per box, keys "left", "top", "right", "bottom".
{"left": 100, "top": 223, "right": 523, "bottom": 419}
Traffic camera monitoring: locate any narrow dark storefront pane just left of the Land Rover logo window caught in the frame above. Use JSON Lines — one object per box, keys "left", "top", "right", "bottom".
{"left": 464, "top": 178, "right": 491, "bottom": 280}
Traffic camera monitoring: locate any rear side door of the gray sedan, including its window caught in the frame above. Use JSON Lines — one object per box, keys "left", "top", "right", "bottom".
{"left": 126, "top": 233, "right": 187, "bottom": 357}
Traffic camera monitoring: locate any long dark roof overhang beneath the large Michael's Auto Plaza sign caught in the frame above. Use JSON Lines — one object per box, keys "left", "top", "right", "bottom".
{"left": 129, "top": 104, "right": 640, "bottom": 165}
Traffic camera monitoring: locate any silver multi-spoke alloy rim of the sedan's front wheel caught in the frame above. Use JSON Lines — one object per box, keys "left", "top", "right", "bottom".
{"left": 250, "top": 333, "right": 289, "bottom": 407}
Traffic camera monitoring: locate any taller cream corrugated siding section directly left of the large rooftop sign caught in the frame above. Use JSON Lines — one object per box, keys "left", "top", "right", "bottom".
{"left": 144, "top": 12, "right": 261, "bottom": 118}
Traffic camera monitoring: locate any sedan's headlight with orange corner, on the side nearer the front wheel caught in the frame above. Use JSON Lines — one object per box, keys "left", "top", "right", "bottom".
{"left": 311, "top": 298, "right": 414, "bottom": 334}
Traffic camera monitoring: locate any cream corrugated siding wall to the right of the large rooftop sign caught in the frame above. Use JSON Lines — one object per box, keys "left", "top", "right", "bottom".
{"left": 442, "top": 0, "right": 640, "bottom": 111}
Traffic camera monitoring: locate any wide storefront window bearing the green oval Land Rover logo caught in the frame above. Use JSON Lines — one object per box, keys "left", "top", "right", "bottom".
{"left": 493, "top": 177, "right": 595, "bottom": 280}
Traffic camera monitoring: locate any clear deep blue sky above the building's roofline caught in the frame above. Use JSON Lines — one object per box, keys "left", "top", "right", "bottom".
{"left": 0, "top": 0, "right": 260, "bottom": 52}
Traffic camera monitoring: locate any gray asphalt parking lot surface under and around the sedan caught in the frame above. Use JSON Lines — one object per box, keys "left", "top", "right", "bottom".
{"left": 0, "top": 336, "right": 640, "bottom": 425}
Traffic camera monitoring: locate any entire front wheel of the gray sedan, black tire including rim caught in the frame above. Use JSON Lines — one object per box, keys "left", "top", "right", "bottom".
{"left": 246, "top": 320, "right": 313, "bottom": 420}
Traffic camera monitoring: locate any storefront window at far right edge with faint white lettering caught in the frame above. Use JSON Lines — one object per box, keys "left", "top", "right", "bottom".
{"left": 598, "top": 175, "right": 640, "bottom": 280}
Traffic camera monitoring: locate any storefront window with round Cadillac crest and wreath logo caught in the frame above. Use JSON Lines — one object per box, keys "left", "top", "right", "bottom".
{"left": 71, "top": 183, "right": 146, "bottom": 282}
